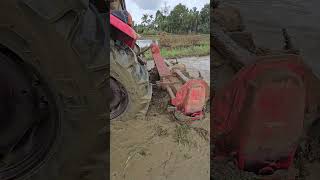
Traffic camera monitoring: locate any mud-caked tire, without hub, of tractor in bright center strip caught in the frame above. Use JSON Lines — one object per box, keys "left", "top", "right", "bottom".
{"left": 110, "top": 41, "right": 152, "bottom": 121}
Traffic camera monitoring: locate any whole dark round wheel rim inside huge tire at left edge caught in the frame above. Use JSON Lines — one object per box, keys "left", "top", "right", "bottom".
{"left": 0, "top": 53, "right": 59, "bottom": 180}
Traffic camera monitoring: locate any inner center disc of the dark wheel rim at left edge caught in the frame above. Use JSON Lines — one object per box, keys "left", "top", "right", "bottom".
{"left": 0, "top": 60, "right": 36, "bottom": 154}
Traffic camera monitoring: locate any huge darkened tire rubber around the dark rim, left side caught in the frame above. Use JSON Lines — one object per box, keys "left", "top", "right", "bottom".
{"left": 0, "top": 0, "right": 110, "bottom": 180}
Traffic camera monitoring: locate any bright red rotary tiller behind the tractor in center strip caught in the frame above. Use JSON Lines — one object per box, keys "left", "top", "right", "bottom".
{"left": 151, "top": 43, "right": 209, "bottom": 120}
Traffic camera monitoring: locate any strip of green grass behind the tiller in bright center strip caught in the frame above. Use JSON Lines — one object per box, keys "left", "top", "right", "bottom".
{"left": 145, "top": 44, "right": 210, "bottom": 60}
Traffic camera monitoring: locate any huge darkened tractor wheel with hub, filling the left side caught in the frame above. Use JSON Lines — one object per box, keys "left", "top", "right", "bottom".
{"left": 0, "top": 0, "right": 109, "bottom": 180}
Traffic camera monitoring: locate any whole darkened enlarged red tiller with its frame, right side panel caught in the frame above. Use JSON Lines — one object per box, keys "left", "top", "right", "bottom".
{"left": 211, "top": 2, "right": 320, "bottom": 179}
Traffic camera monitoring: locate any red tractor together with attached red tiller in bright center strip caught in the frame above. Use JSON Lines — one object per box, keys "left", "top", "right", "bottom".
{"left": 110, "top": 0, "right": 209, "bottom": 120}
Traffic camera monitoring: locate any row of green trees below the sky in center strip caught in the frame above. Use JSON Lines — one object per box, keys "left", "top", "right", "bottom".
{"left": 134, "top": 3, "right": 210, "bottom": 34}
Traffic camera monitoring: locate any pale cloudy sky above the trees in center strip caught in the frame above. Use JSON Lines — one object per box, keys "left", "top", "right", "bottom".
{"left": 126, "top": 0, "right": 210, "bottom": 24}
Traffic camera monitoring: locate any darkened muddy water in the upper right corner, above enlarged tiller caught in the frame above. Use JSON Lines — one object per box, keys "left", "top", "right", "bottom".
{"left": 221, "top": 0, "right": 320, "bottom": 77}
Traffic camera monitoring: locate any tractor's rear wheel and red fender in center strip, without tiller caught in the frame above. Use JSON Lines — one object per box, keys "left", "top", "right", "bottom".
{"left": 110, "top": 1, "right": 152, "bottom": 120}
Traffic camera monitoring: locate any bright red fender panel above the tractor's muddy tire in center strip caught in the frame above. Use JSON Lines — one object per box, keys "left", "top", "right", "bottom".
{"left": 110, "top": 13, "right": 138, "bottom": 48}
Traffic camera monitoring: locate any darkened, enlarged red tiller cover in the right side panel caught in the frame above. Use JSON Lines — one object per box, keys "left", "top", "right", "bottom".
{"left": 213, "top": 55, "right": 306, "bottom": 175}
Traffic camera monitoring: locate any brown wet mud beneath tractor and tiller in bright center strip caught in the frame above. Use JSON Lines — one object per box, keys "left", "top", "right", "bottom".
{"left": 110, "top": 58, "right": 210, "bottom": 180}
